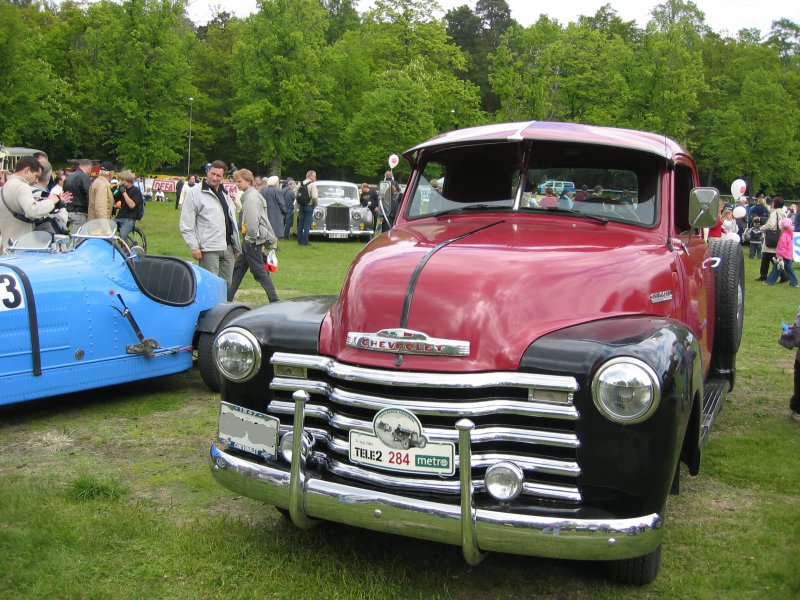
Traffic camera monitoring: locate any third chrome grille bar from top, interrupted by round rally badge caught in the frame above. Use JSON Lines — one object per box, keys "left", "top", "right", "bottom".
{"left": 267, "top": 400, "right": 580, "bottom": 448}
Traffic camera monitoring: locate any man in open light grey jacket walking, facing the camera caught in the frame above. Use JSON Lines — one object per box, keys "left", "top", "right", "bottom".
{"left": 179, "top": 160, "right": 241, "bottom": 286}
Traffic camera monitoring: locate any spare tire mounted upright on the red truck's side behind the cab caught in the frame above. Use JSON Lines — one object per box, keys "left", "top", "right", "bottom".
{"left": 709, "top": 239, "right": 744, "bottom": 357}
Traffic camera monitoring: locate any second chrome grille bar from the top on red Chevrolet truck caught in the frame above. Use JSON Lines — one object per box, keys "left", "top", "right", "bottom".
{"left": 269, "top": 377, "right": 580, "bottom": 421}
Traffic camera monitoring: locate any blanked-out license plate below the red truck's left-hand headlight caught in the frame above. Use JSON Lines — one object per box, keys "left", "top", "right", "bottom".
{"left": 219, "top": 402, "right": 280, "bottom": 458}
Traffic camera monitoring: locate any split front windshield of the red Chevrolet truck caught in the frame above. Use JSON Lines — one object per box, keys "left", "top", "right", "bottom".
{"left": 406, "top": 142, "right": 663, "bottom": 227}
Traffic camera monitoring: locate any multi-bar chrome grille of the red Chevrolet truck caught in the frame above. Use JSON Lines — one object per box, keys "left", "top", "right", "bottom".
{"left": 267, "top": 352, "right": 582, "bottom": 506}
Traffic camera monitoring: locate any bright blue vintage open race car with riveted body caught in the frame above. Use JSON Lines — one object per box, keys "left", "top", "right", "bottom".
{"left": 0, "top": 219, "right": 247, "bottom": 405}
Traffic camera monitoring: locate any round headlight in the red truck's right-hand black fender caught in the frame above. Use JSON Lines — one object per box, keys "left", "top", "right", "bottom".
{"left": 592, "top": 356, "right": 661, "bottom": 425}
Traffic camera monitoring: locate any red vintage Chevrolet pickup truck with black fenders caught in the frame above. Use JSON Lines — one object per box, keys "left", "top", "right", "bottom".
{"left": 210, "top": 122, "right": 744, "bottom": 583}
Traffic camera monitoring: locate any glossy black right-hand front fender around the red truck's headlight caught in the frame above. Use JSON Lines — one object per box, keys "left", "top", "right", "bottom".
{"left": 520, "top": 316, "right": 703, "bottom": 514}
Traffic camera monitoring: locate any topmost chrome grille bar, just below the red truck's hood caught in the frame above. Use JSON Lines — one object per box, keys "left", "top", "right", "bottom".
{"left": 270, "top": 352, "right": 579, "bottom": 392}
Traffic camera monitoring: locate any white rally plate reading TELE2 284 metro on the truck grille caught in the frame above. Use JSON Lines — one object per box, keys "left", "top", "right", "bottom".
{"left": 350, "top": 430, "right": 455, "bottom": 475}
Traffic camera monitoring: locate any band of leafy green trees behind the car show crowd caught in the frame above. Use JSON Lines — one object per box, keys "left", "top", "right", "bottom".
{"left": 0, "top": 0, "right": 800, "bottom": 192}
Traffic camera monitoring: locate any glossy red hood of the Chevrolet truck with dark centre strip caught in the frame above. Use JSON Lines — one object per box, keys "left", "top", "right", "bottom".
{"left": 320, "top": 215, "right": 673, "bottom": 372}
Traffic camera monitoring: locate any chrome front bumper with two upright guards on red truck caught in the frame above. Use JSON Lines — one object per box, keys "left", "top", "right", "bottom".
{"left": 210, "top": 401, "right": 663, "bottom": 565}
